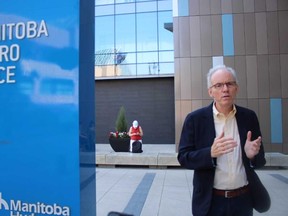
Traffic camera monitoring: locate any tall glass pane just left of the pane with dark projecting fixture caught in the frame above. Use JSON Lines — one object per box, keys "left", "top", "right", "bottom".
{"left": 137, "top": 12, "right": 158, "bottom": 51}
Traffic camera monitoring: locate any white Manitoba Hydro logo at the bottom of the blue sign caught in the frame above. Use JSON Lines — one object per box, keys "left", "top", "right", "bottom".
{"left": 0, "top": 192, "right": 70, "bottom": 216}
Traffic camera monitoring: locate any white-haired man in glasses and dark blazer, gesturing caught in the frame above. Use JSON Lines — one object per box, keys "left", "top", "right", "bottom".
{"left": 178, "top": 65, "right": 266, "bottom": 216}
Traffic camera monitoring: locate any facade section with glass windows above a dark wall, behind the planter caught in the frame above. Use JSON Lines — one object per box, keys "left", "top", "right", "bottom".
{"left": 95, "top": 0, "right": 175, "bottom": 144}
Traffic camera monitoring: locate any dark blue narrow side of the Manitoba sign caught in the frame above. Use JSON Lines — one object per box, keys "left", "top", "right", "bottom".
{"left": 79, "top": 0, "right": 96, "bottom": 216}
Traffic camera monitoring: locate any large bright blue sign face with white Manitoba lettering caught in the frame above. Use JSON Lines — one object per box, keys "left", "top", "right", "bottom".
{"left": 0, "top": 0, "right": 96, "bottom": 216}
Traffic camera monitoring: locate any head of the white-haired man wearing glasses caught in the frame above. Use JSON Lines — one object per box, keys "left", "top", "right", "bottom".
{"left": 207, "top": 65, "right": 238, "bottom": 112}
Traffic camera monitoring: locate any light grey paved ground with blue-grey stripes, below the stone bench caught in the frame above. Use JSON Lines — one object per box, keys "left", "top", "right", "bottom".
{"left": 96, "top": 167, "right": 288, "bottom": 216}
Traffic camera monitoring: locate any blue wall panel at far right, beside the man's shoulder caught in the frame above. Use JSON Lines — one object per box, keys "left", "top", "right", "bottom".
{"left": 270, "top": 98, "right": 283, "bottom": 143}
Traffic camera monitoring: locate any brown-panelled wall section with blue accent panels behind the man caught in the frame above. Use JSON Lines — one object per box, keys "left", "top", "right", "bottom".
{"left": 173, "top": 0, "right": 288, "bottom": 153}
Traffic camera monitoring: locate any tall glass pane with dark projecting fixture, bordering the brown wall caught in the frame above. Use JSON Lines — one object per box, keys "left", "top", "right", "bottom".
{"left": 158, "top": 11, "right": 174, "bottom": 50}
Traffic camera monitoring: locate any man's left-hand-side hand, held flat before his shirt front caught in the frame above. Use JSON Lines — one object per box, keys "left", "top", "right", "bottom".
{"left": 211, "top": 131, "right": 237, "bottom": 158}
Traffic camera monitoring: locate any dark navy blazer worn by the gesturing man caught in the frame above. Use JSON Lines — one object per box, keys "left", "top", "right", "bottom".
{"left": 178, "top": 103, "right": 266, "bottom": 216}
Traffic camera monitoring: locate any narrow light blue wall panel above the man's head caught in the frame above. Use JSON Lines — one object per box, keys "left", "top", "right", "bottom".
{"left": 222, "top": 14, "right": 234, "bottom": 56}
